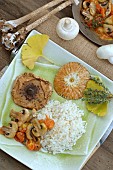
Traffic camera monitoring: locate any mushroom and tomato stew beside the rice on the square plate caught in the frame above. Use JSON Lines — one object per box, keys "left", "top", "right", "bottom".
{"left": 0, "top": 109, "right": 55, "bottom": 150}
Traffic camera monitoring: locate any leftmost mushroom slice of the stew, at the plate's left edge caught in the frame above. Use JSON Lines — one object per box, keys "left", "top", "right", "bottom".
{"left": 2, "top": 121, "right": 18, "bottom": 138}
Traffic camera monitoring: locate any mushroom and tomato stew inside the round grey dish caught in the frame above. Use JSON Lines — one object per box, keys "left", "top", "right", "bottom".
{"left": 81, "top": 0, "right": 113, "bottom": 40}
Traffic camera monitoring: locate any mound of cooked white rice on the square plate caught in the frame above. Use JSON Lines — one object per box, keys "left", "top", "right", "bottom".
{"left": 38, "top": 100, "right": 86, "bottom": 154}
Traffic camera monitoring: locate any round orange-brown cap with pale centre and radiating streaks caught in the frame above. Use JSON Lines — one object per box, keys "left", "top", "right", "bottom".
{"left": 54, "top": 62, "right": 90, "bottom": 99}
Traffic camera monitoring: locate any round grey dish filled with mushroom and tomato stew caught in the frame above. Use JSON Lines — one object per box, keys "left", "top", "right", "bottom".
{"left": 72, "top": 0, "right": 113, "bottom": 45}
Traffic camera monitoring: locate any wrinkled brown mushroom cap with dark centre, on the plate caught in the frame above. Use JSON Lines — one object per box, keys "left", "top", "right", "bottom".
{"left": 11, "top": 73, "right": 52, "bottom": 110}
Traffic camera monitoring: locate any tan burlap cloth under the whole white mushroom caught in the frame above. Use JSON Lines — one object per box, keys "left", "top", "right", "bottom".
{"left": 27, "top": 13, "right": 113, "bottom": 80}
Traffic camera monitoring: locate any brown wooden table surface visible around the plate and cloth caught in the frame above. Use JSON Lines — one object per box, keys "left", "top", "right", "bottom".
{"left": 0, "top": 0, "right": 113, "bottom": 170}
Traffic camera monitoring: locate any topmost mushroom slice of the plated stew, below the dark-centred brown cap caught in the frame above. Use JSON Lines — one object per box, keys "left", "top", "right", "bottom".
{"left": 10, "top": 109, "right": 31, "bottom": 127}
